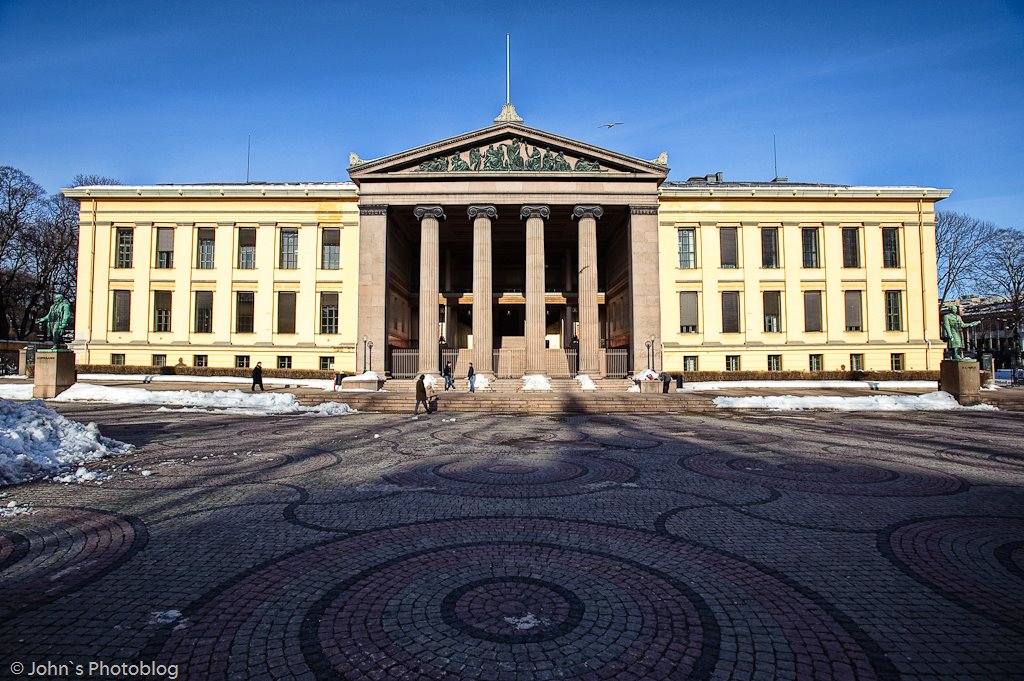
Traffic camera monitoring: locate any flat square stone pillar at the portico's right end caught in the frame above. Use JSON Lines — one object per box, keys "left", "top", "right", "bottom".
{"left": 630, "top": 201, "right": 665, "bottom": 371}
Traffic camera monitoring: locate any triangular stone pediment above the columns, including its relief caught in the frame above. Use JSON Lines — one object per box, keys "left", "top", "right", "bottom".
{"left": 348, "top": 123, "right": 669, "bottom": 183}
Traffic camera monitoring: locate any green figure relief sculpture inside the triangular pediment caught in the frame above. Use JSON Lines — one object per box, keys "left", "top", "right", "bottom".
{"left": 413, "top": 137, "right": 606, "bottom": 173}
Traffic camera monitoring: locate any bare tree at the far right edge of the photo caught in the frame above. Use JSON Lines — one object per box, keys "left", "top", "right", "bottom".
{"left": 976, "top": 229, "right": 1024, "bottom": 367}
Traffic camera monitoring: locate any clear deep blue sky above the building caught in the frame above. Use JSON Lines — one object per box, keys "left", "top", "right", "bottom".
{"left": 0, "top": 0, "right": 1024, "bottom": 226}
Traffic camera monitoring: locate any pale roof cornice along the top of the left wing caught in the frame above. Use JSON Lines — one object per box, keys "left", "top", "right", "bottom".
{"left": 60, "top": 182, "right": 358, "bottom": 200}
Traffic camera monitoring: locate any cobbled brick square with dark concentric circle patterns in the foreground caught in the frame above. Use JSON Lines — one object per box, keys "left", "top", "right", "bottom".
{"left": 0, "top": 405, "right": 1024, "bottom": 680}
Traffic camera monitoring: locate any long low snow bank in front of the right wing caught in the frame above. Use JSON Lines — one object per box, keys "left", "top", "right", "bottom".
{"left": 715, "top": 392, "right": 995, "bottom": 412}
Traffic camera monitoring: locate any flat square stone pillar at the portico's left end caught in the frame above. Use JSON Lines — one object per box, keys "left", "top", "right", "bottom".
{"left": 356, "top": 204, "right": 388, "bottom": 378}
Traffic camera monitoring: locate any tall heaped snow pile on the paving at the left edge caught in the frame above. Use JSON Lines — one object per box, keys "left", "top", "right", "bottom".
{"left": 0, "top": 399, "right": 132, "bottom": 484}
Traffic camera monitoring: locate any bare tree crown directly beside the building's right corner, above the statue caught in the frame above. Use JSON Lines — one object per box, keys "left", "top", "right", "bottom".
{"left": 935, "top": 211, "right": 995, "bottom": 302}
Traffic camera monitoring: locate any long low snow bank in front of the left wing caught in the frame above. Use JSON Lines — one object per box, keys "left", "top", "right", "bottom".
{"left": 54, "top": 383, "right": 354, "bottom": 416}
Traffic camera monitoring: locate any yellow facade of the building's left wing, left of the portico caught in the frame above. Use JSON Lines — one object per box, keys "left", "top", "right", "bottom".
{"left": 70, "top": 183, "right": 358, "bottom": 371}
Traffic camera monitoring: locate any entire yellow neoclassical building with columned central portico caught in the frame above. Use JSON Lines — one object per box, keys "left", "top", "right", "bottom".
{"left": 65, "top": 109, "right": 950, "bottom": 376}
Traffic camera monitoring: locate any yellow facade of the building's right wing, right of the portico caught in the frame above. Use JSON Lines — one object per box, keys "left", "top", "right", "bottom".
{"left": 658, "top": 183, "right": 949, "bottom": 371}
